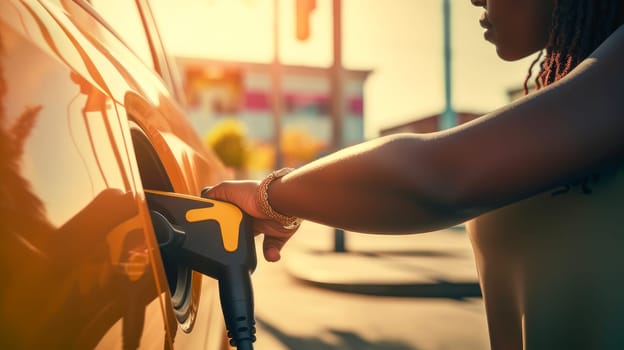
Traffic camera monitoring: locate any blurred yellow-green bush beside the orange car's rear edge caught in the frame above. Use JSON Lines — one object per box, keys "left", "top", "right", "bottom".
{"left": 205, "top": 118, "right": 249, "bottom": 172}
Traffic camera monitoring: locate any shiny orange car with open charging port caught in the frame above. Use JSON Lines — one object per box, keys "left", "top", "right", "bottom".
{"left": 0, "top": 0, "right": 235, "bottom": 349}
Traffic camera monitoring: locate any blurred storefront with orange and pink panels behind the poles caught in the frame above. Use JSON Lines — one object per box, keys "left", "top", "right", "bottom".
{"left": 177, "top": 57, "right": 370, "bottom": 176}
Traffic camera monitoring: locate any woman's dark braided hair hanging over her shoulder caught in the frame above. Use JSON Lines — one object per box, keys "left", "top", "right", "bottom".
{"left": 524, "top": 0, "right": 623, "bottom": 95}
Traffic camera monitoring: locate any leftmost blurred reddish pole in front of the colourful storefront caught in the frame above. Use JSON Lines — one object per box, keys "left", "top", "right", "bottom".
{"left": 271, "top": 0, "right": 284, "bottom": 169}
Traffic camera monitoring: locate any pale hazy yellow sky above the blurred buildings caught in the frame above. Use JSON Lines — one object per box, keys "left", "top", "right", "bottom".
{"left": 151, "top": 0, "right": 532, "bottom": 138}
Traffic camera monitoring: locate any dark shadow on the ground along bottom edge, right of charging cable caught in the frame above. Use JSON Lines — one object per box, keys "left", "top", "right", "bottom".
{"left": 256, "top": 318, "right": 417, "bottom": 350}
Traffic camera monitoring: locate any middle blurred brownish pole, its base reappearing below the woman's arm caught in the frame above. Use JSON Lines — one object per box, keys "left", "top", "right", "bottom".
{"left": 330, "top": 0, "right": 346, "bottom": 252}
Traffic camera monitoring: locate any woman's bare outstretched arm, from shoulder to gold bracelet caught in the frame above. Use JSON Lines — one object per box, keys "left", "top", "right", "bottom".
{"left": 209, "top": 27, "right": 624, "bottom": 260}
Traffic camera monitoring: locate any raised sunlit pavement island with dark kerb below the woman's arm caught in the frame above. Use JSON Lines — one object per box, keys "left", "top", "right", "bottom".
{"left": 282, "top": 222, "right": 481, "bottom": 299}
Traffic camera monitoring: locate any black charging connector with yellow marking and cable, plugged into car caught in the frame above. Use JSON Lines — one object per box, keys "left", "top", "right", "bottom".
{"left": 145, "top": 190, "right": 257, "bottom": 350}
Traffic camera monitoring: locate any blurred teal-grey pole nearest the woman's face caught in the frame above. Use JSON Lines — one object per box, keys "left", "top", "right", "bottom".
{"left": 438, "top": 0, "right": 457, "bottom": 130}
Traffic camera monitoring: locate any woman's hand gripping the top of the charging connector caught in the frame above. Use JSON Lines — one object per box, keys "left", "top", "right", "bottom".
{"left": 202, "top": 181, "right": 297, "bottom": 261}
